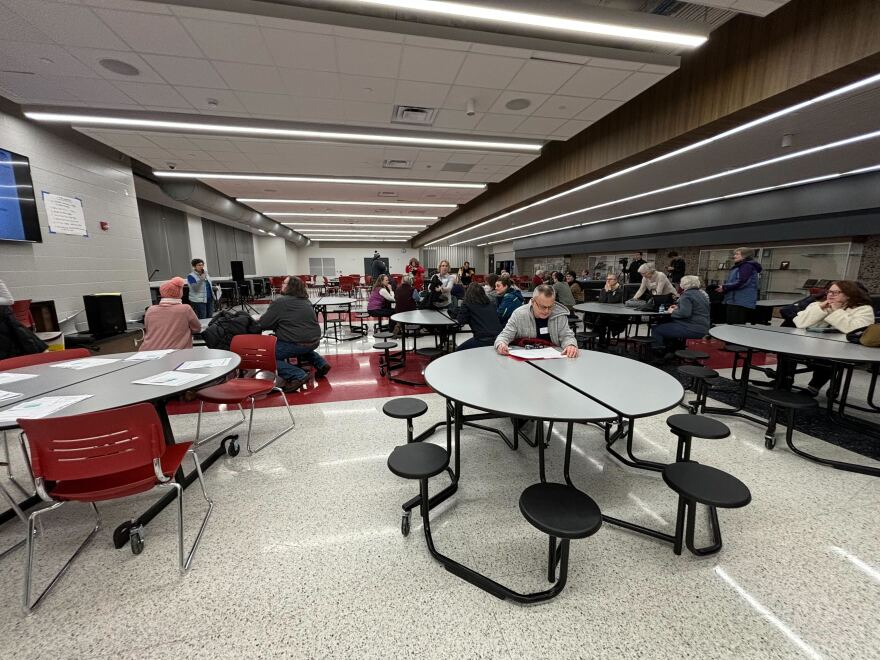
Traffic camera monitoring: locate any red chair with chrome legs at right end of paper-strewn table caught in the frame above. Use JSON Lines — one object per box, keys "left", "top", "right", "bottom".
{"left": 195, "top": 335, "right": 296, "bottom": 454}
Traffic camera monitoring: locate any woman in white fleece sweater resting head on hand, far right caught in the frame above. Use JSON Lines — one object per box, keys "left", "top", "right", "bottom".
{"left": 794, "top": 280, "right": 874, "bottom": 396}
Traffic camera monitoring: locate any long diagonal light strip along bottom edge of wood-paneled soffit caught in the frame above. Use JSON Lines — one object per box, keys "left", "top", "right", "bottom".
{"left": 425, "top": 73, "right": 880, "bottom": 247}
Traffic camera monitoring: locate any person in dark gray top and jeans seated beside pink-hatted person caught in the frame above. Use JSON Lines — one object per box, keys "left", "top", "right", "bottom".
{"left": 260, "top": 277, "right": 330, "bottom": 392}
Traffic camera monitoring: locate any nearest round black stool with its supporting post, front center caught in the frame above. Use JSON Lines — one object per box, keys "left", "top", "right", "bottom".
{"left": 519, "top": 482, "right": 602, "bottom": 593}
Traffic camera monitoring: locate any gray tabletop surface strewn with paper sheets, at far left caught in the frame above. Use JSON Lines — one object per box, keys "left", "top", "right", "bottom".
{"left": 0, "top": 348, "right": 241, "bottom": 430}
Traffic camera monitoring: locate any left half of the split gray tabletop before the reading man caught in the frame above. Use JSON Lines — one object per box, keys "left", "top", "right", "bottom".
{"left": 425, "top": 346, "right": 617, "bottom": 421}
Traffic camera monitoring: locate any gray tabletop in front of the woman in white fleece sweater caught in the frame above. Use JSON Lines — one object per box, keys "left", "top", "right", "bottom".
{"left": 709, "top": 325, "right": 880, "bottom": 362}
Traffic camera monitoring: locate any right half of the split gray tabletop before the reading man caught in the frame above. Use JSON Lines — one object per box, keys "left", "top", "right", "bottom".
{"left": 534, "top": 351, "right": 684, "bottom": 417}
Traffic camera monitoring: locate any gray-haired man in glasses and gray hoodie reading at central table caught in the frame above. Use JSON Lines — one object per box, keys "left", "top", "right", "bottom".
{"left": 495, "top": 284, "right": 578, "bottom": 357}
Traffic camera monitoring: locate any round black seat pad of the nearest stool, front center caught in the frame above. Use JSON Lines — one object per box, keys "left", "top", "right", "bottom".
{"left": 519, "top": 483, "right": 602, "bottom": 539}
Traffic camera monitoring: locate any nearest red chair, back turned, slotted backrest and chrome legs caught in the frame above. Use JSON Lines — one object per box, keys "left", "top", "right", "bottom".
{"left": 18, "top": 403, "right": 214, "bottom": 611}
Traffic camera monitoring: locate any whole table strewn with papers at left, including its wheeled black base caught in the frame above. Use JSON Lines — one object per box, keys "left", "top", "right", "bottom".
{"left": 0, "top": 348, "right": 241, "bottom": 548}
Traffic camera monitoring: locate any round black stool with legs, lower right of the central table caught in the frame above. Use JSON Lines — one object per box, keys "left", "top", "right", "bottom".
{"left": 663, "top": 461, "right": 752, "bottom": 556}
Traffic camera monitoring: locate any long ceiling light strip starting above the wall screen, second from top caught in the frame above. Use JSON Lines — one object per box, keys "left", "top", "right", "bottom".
{"left": 24, "top": 112, "right": 543, "bottom": 152}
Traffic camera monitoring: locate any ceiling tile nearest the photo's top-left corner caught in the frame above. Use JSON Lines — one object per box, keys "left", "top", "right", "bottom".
{"left": 4, "top": 0, "right": 129, "bottom": 50}
